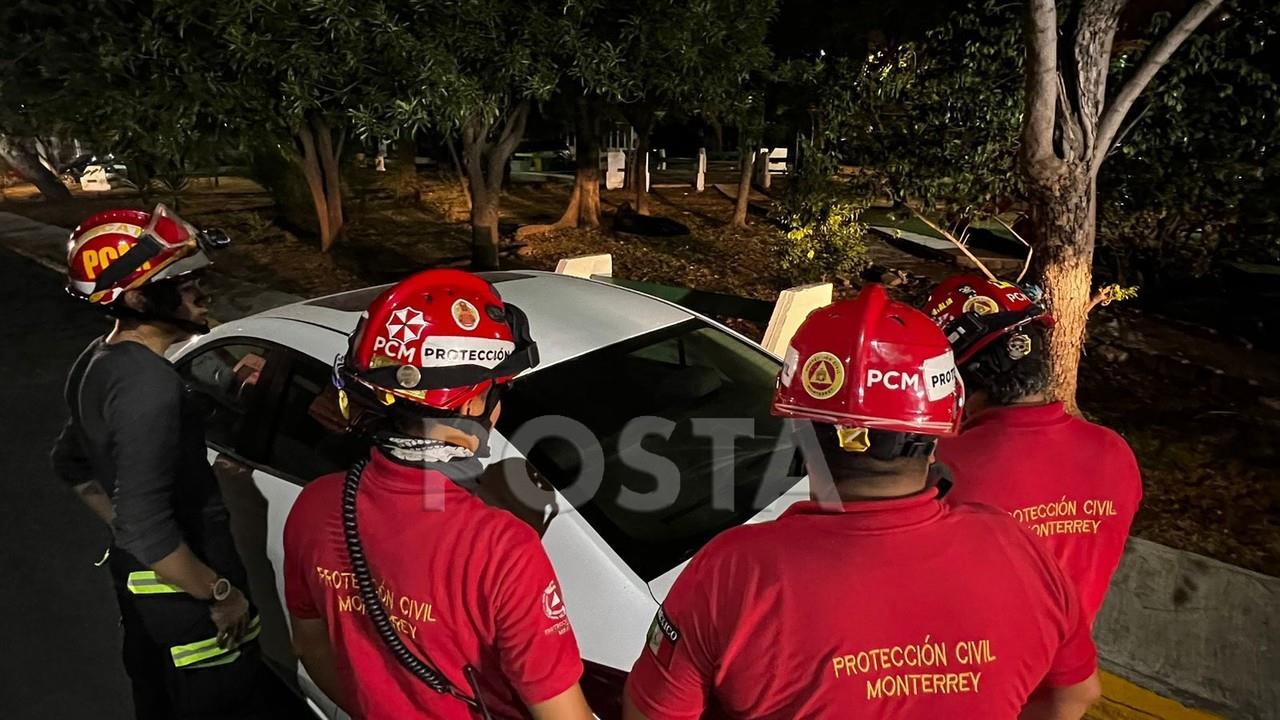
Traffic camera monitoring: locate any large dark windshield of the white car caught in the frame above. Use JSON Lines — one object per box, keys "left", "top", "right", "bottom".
{"left": 498, "top": 320, "right": 799, "bottom": 580}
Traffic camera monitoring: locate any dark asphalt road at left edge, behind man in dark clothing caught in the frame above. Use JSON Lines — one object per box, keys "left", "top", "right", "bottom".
{"left": 0, "top": 249, "right": 301, "bottom": 720}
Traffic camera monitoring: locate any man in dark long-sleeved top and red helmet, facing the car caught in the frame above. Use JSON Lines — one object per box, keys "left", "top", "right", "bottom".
{"left": 52, "top": 205, "right": 266, "bottom": 719}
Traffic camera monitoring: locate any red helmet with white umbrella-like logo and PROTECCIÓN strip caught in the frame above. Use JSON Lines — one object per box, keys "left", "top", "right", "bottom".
{"left": 334, "top": 270, "right": 538, "bottom": 410}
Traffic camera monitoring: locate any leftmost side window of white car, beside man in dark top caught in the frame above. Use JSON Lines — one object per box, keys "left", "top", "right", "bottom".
{"left": 178, "top": 343, "right": 268, "bottom": 450}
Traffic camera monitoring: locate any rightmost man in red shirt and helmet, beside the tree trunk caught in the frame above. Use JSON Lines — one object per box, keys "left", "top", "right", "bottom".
{"left": 928, "top": 275, "right": 1142, "bottom": 625}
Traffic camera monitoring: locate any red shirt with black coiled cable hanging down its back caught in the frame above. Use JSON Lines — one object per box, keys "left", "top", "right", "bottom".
{"left": 284, "top": 450, "right": 582, "bottom": 720}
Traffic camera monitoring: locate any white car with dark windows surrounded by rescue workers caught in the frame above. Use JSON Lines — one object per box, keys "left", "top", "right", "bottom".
{"left": 174, "top": 272, "right": 808, "bottom": 717}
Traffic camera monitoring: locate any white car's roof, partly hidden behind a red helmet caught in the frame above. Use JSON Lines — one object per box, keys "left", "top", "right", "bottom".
{"left": 241, "top": 270, "right": 696, "bottom": 366}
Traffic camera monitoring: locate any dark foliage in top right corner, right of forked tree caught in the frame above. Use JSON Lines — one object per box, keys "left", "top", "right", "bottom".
{"left": 1098, "top": 0, "right": 1280, "bottom": 284}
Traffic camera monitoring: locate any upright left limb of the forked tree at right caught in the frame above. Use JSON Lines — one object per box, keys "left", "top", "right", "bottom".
{"left": 1023, "top": 0, "right": 1059, "bottom": 172}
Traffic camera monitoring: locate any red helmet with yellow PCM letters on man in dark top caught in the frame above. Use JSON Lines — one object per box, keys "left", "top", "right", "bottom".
{"left": 67, "top": 205, "right": 225, "bottom": 305}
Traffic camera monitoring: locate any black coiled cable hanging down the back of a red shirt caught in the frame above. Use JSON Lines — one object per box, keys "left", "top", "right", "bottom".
{"left": 342, "top": 459, "right": 492, "bottom": 720}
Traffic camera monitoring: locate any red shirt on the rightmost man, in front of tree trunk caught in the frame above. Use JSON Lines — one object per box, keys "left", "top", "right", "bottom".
{"left": 938, "top": 402, "right": 1142, "bottom": 624}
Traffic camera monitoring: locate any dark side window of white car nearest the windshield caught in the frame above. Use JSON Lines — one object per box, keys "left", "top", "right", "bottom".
{"left": 266, "top": 355, "right": 369, "bottom": 483}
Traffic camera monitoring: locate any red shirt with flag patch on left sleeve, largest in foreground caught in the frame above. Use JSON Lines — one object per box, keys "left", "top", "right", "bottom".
{"left": 627, "top": 489, "right": 1097, "bottom": 720}
